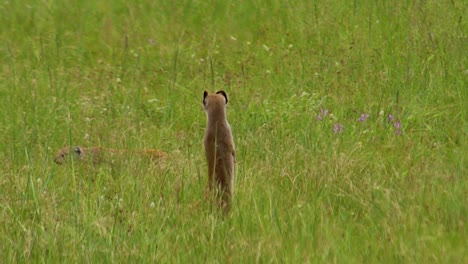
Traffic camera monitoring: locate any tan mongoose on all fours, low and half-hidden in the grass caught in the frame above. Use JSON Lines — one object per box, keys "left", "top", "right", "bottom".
{"left": 54, "top": 146, "right": 166, "bottom": 165}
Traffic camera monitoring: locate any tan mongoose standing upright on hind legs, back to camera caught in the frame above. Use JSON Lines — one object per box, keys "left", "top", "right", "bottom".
{"left": 203, "top": 91, "right": 235, "bottom": 212}
